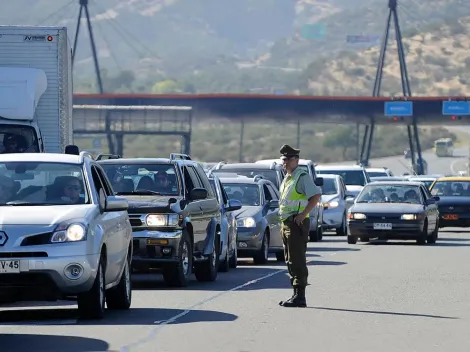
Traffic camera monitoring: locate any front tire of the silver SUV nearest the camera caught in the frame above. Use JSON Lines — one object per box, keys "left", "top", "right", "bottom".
{"left": 77, "top": 257, "right": 106, "bottom": 319}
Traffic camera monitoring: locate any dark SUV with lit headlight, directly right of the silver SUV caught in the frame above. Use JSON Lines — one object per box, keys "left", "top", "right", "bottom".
{"left": 97, "top": 154, "right": 220, "bottom": 287}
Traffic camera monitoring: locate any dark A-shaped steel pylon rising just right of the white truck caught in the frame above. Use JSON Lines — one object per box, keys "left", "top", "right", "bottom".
{"left": 72, "top": 0, "right": 116, "bottom": 154}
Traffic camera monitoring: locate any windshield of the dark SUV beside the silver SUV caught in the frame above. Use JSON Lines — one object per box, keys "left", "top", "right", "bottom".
{"left": 101, "top": 163, "right": 180, "bottom": 196}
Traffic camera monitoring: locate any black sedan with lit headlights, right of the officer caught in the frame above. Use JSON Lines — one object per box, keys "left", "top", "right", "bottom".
{"left": 346, "top": 181, "right": 439, "bottom": 244}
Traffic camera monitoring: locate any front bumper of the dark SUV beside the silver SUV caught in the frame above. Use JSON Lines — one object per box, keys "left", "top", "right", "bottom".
{"left": 132, "top": 230, "right": 183, "bottom": 268}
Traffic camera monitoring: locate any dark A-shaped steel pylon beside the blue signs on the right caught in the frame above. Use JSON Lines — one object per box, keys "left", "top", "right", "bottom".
{"left": 361, "top": 0, "right": 424, "bottom": 175}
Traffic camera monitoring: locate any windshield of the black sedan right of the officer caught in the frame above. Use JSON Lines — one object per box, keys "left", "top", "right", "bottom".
{"left": 356, "top": 184, "right": 423, "bottom": 204}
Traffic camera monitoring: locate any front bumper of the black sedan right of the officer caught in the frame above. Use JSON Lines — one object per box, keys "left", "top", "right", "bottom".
{"left": 348, "top": 220, "right": 424, "bottom": 240}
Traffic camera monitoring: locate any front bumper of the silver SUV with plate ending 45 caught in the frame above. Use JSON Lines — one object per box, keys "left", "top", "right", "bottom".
{"left": 0, "top": 254, "right": 100, "bottom": 300}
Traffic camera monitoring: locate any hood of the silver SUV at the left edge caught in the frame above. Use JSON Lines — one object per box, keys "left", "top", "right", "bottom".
{"left": 0, "top": 204, "right": 97, "bottom": 227}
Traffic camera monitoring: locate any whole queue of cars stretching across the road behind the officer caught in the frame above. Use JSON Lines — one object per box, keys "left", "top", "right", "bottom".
{"left": 0, "top": 152, "right": 470, "bottom": 319}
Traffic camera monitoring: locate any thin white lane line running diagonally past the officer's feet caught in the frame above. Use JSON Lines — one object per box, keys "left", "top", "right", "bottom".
{"left": 119, "top": 253, "right": 336, "bottom": 352}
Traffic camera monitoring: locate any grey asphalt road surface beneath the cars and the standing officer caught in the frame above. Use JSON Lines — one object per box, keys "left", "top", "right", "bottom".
{"left": 0, "top": 148, "right": 470, "bottom": 352}
